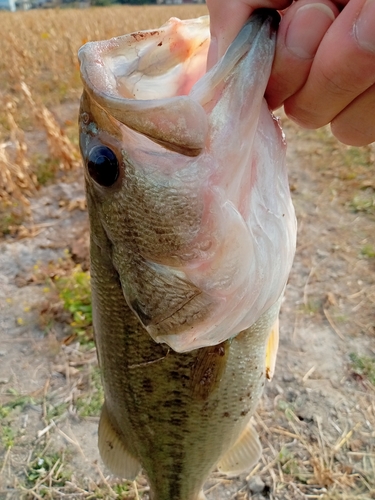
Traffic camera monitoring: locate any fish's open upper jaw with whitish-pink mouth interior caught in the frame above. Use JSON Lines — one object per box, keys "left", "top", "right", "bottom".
{"left": 79, "top": 16, "right": 210, "bottom": 156}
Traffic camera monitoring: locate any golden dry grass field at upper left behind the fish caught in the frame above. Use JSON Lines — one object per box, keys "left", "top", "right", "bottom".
{"left": 0, "top": 5, "right": 206, "bottom": 235}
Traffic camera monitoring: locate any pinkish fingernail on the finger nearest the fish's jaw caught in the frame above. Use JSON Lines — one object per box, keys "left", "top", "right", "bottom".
{"left": 285, "top": 0, "right": 336, "bottom": 59}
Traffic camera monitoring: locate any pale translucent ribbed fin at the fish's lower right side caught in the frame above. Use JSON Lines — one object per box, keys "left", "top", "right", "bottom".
{"left": 218, "top": 422, "right": 262, "bottom": 476}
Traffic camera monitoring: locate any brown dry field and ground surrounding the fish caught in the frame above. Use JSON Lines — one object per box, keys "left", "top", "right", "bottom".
{"left": 0, "top": 6, "right": 375, "bottom": 500}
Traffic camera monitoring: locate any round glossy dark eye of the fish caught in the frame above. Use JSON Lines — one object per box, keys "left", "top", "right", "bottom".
{"left": 87, "top": 146, "right": 120, "bottom": 187}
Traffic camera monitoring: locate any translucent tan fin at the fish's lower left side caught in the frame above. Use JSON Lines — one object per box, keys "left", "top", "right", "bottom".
{"left": 98, "top": 403, "right": 142, "bottom": 481}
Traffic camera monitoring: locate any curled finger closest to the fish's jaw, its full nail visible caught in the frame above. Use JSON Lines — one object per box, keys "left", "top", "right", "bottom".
{"left": 266, "top": 0, "right": 339, "bottom": 109}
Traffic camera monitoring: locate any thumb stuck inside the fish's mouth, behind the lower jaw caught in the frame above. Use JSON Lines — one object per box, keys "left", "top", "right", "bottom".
{"left": 206, "top": 0, "right": 292, "bottom": 69}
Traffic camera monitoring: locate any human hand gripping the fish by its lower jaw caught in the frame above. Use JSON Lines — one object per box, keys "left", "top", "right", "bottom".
{"left": 207, "top": 0, "right": 375, "bottom": 146}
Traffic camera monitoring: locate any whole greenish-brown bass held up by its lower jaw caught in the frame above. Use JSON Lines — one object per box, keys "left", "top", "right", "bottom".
{"left": 79, "top": 10, "right": 296, "bottom": 500}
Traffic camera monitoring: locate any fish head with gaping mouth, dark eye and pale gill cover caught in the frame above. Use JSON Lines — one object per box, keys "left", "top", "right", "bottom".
{"left": 79, "top": 7, "right": 296, "bottom": 352}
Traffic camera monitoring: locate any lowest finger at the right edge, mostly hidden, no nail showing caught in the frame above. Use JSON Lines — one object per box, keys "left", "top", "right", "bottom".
{"left": 331, "top": 85, "right": 375, "bottom": 146}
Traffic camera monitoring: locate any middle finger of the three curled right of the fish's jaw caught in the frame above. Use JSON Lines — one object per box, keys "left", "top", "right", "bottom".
{"left": 284, "top": 0, "right": 375, "bottom": 128}
